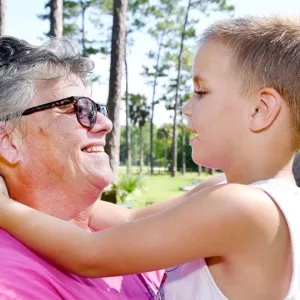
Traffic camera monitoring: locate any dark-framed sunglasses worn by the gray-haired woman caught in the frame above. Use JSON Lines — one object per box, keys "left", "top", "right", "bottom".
{"left": 10, "top": 96, "right": 108, "bottom": 128}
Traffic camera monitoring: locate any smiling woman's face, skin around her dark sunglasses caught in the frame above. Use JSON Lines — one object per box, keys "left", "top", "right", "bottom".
{"left": 17, "top": 75, "right": 112, "bottom": 194}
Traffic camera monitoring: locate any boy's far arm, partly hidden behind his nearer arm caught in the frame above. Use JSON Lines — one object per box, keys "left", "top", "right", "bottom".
{"left": 89, "top": 173, "right": 226, "bottom": 231}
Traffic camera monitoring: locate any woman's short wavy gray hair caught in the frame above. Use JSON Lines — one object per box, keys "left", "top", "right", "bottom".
{"left": 0, "top": 36, "right": 94, "bottom": 121}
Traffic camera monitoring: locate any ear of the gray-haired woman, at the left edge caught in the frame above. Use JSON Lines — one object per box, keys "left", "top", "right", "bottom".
{"left": 0, "top": 122, "right": 21, "bottom": 165}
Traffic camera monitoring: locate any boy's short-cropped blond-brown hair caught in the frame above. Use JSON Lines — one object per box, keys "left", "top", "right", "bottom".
{"left": 200, "top": 16, "right": 300, "bottom": 148}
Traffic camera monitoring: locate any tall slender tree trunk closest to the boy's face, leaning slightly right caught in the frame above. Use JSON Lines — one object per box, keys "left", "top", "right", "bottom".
{"left": 171, "top": 0, "right": 191, "bottom": 177}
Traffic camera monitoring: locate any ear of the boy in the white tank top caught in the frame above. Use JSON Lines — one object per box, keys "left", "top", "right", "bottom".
{"left": 250, "top": 88, "right": 284, "bottom": 132}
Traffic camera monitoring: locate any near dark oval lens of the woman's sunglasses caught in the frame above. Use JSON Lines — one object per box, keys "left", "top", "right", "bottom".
{"left": 76, "top": 97, "right": 97, "bottom": 128}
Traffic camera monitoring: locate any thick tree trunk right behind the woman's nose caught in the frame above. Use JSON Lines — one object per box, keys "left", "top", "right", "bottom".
{"left": 106, "top": 0, "right": 127, "bottom": 178}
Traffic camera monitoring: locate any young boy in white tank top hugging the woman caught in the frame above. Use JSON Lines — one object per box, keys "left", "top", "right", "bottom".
{"left": 0, "top": 17, "right": 300, "bottom": 300}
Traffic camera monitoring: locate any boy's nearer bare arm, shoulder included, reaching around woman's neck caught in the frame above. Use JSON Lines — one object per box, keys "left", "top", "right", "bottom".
{"left": 0, "top": 178, "right": 278, "bottom": 277}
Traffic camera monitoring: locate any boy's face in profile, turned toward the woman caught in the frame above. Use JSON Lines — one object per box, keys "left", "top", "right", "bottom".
{"left": 183, "top": 42, "right": 251, "bottom": 169}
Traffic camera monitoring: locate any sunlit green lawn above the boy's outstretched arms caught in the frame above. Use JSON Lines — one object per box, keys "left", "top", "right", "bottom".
{"left": 129, "top": 173, "right": 209, "bottom": 208}
